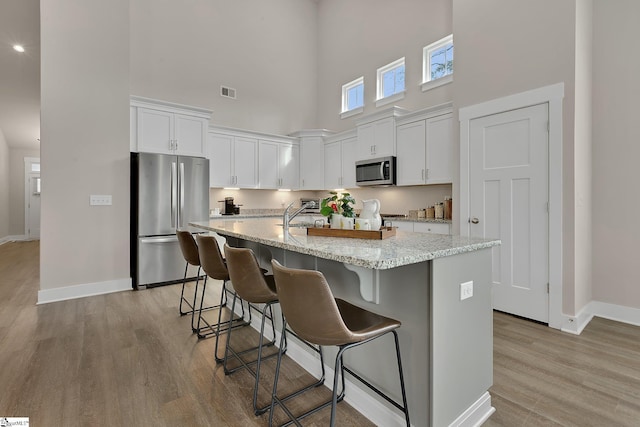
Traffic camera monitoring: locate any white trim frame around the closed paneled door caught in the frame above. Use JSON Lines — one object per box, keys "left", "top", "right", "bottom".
{"left": 458, "top": 83, "right": 565, "bottom": 329}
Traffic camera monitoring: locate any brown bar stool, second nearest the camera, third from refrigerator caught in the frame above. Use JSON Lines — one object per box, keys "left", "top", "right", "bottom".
{"left": 224, "top": 244, "right": 324, "bottom": 415}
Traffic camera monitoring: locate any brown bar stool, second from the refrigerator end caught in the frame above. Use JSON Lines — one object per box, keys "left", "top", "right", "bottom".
{"left": 196, "top": 234, "right": 246, "bottom": 344}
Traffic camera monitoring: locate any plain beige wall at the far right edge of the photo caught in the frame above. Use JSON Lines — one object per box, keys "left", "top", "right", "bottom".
{"left": 593, "top": 0, "right": 640, "bottom": 308}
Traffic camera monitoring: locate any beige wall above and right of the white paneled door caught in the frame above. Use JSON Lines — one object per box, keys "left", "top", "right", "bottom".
{"left": 453, "top": 0, "right": 590, "bottom": 315}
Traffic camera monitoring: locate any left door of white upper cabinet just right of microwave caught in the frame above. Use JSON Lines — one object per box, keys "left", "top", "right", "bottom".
{"left": 396, "top": 120, "right": 426, "bottom": 185}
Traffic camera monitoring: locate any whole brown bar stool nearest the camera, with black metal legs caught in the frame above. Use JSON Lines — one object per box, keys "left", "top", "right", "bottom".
{"left": 269, "top": 260, "right": 411, "bottom": 426}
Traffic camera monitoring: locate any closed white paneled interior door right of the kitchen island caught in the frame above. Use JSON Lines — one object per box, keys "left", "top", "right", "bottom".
{"left": 469, "top": 103, "right": 549, "bottom": 322}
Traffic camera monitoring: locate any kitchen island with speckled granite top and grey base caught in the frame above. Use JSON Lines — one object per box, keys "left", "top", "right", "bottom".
{"left": 190, "top": 218, "right": 500, "bottom": 426}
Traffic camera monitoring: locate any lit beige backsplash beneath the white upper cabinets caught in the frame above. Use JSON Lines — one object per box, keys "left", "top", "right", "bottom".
{"left": 209, "top": 184, "right": 455, "bottom": 215}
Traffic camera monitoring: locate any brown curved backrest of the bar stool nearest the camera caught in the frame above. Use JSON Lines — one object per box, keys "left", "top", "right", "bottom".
{"left": 271, "top": 260, "right": 352, "bottom": 345}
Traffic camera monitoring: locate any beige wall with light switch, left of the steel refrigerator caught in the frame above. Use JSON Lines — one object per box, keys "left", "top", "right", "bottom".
{"left": 40, "top": 0, "right": 130, "bottom": 290}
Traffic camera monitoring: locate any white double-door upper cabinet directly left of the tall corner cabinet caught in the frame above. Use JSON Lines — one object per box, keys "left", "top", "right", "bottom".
{"left": 258, "top": 140, "right": 299, "bottom": 189}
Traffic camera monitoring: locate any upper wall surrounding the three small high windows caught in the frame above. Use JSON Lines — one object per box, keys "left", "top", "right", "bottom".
{"left": 317, "top": 0, "right": 452, "bottom": 131}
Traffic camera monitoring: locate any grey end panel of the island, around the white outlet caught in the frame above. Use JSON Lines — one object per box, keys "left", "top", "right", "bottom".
{"left": 430, "top": 249, "right": 493, "bottom": 426}
